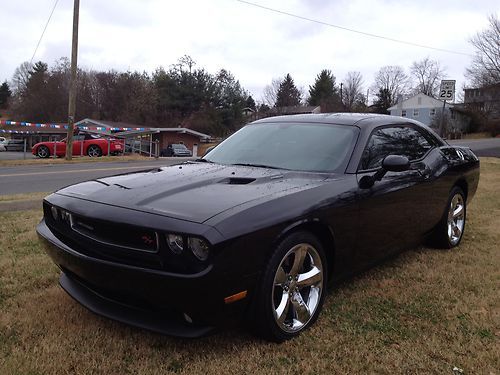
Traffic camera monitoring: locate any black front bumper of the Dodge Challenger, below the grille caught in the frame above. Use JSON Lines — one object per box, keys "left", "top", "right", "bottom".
{"left": 37, "top": 220, "right": 255, "bottom": 337}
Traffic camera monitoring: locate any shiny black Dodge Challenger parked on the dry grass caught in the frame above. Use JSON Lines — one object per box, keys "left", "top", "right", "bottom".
{"left": 37, "top": 114, "right": 479, "bottom": 341}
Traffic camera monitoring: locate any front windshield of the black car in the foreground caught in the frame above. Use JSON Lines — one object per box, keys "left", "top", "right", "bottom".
{"left": 203, "top": 123, "right": 357, "bottom": 172}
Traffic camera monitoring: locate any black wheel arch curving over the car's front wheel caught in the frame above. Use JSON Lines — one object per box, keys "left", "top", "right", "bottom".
{"left": 273, "top": 219, "right": 335, "bottom": 280}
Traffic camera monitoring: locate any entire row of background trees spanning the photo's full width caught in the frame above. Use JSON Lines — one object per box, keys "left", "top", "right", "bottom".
{"left": 0, "top": 15, "right": 500, "bottom": 136}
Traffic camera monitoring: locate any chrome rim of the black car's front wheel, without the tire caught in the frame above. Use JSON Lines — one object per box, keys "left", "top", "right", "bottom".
{"left": 272, "top": 243, "right": 324, "bottom": 333}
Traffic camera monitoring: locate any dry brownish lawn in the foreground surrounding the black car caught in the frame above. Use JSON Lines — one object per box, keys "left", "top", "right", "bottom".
{"left": 0, "top": 159, "right": 500, "bottom": 374}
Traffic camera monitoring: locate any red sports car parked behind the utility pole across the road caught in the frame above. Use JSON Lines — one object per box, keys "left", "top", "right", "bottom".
{"left": 31, "top": 134, "right": 123, "bottom": 158}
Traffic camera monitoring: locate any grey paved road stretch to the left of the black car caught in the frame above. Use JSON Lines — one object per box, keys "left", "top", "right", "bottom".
{"left": 0, "top": 158, "right": 187, "bottom": 195}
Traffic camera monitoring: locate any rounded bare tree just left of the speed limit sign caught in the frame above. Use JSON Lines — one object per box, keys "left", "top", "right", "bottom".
{"left": 410, "top": 57, "right": 446, "bottom": 98}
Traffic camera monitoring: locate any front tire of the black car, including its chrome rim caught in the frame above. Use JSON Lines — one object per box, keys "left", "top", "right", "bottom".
{"left": 252, "top": 232, "right": 327, "bottom": 342}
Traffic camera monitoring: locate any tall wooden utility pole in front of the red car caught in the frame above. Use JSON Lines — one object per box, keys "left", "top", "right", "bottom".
{"left": 66, "top": 0, "right": 80, "bottom": 160}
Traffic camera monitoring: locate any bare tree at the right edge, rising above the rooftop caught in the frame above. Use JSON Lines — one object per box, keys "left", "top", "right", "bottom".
{"left": 466, "top": 14, "right": 500, "bottom": 87}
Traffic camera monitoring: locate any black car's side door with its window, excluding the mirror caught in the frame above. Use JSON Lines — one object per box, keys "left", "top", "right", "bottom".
{"left": 357, "top": 124, "right": 437, "bottom": 265}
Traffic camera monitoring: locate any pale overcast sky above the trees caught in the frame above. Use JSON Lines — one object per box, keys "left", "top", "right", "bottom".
{"left": 0, "top": 0, "right": 500, "bottom": 100}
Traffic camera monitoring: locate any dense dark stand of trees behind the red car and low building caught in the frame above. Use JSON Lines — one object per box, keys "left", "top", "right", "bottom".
{"left": 5, "top": 56, "right": 255, "bottom": 136}
